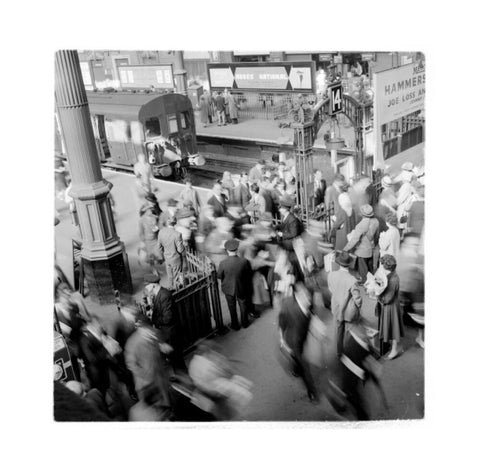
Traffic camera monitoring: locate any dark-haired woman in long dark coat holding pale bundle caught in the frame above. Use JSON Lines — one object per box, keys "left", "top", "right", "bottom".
{"left": 375, "top": 255, "right": 404, "bottom": 360}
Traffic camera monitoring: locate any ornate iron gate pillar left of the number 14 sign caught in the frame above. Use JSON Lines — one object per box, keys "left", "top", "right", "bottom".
{"left": 293, "top": 121, "right": 315, "bottom": 223}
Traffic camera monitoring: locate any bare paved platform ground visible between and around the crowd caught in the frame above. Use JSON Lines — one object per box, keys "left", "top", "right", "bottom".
{"left": 55, "top": 171, "right": 424, "bottom": 421}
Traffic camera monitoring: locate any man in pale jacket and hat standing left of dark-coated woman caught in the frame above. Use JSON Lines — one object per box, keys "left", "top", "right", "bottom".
{"left": 328, "top": 251, "right": 362, "bottom": 357}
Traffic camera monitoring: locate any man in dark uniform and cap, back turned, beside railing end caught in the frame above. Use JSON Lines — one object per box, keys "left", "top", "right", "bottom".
{"left": 218, "top": 239, "right": 253, "bottom": 330}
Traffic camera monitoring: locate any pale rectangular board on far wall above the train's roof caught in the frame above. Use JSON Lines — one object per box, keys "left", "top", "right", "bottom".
{"left": 118, "top": 64, "right": 175, "bottom": 90}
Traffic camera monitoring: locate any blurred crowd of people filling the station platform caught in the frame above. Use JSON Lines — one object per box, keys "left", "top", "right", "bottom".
{"left": 56, "top": 149, "right": 424, "bottom": 420}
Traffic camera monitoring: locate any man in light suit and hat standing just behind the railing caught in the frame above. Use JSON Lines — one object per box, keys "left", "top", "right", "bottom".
{"left": 158, "top": 216, "right": 185, "bottom": 287}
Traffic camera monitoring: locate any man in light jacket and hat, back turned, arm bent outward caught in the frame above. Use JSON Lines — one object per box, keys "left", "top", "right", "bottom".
{"left": 344, "top": 204, "right": 379, "bottom": 282}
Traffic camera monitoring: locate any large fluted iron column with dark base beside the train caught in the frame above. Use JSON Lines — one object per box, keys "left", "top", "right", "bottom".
{"left": 55, "top": 50, "right": 132, "bottom": 303}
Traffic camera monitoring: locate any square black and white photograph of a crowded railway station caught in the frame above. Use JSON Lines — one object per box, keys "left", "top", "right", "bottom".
{"left": 52, "top": 50, "right": 428, "bottom": 422}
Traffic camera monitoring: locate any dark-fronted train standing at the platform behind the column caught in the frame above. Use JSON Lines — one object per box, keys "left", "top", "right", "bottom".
{"left": 55, "top": 90, "right": 205, "bottom": 179}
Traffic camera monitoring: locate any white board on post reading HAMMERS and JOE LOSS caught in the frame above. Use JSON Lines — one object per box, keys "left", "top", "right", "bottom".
{"left": 374, "top": 62, "right": 425, "bottom": 168}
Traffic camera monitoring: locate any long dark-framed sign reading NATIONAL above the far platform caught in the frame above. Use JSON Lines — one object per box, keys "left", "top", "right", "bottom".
{"left": 208, "top": 61, "right": 315, "bottom": 93}
